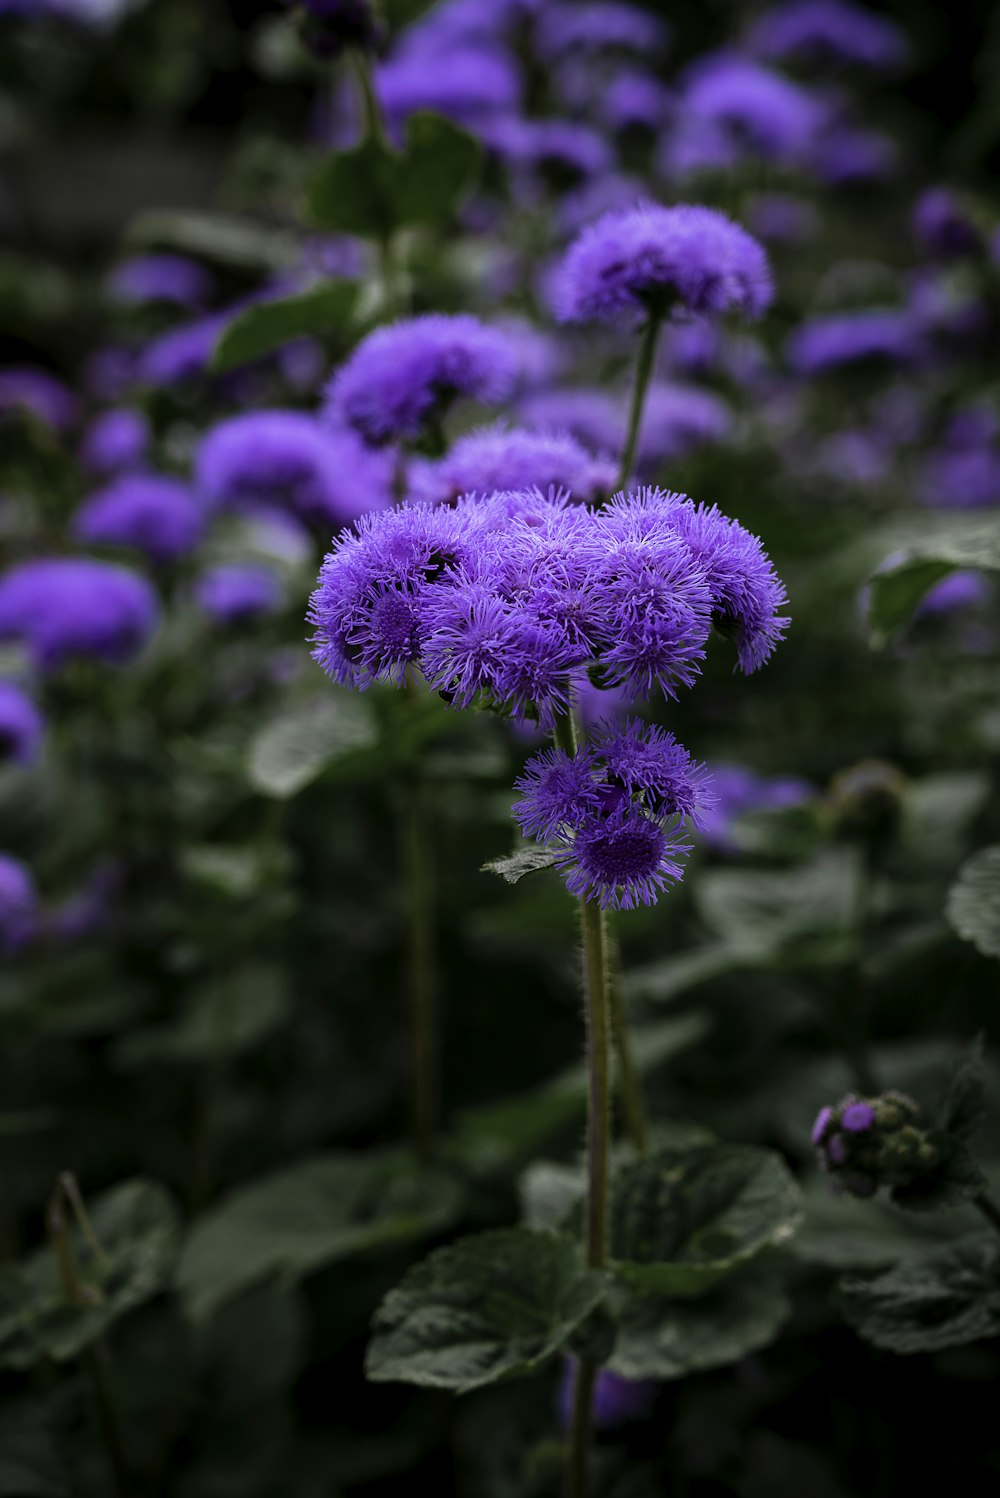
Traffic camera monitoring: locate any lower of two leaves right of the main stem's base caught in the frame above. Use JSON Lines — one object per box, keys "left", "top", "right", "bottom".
{"left": 608, "top": 1263, "right": 789, "bottom": 1378}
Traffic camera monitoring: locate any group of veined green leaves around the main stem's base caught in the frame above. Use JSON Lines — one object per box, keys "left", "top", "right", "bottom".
{"left": 367, "top": 1144, "right": 799, "bottom": 1392}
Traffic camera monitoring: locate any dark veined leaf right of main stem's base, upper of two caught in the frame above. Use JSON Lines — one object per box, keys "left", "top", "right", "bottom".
{"left": 609, "top": 1144, "right": 802, "bottom": 1296}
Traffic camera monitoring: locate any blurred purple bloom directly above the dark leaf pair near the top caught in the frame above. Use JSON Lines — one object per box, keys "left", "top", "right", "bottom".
{"left": 376, "top": 42, "right": 521, "bottom": 129}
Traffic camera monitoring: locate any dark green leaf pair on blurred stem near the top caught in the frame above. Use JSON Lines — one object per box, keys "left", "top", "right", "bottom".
{"left": 305, "top": 112, "right": 482, "bottom": 240}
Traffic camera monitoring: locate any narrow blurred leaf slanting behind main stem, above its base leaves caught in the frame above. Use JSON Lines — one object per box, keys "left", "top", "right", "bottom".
{"left": 449, "top": 1014, "right": 708, "bottom": 1168}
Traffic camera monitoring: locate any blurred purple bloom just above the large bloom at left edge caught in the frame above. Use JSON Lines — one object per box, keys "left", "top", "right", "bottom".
{"left": 72, "top": 473, "right": 205, "bottom": 565}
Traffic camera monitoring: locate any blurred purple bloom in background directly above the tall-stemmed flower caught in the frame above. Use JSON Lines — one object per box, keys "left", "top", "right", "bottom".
{"left": 665, "top": 52, "right": 826, "bottom": 175}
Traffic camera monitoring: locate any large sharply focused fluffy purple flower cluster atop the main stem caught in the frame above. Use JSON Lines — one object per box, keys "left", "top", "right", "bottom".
{"left": 310, "top": 488, "right": 787, "bottom": 707}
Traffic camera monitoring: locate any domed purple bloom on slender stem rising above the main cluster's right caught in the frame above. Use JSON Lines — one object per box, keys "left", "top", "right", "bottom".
{"left": 555, "top": 202, "right": 772, "bottom": 322}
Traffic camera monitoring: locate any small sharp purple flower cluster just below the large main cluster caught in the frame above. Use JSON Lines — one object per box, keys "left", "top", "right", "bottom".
{"left": 513, "top": 719, "right": 711, "bottom": 909}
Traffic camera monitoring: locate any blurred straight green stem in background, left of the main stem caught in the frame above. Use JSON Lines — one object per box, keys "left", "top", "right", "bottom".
{"left": 400, "top": 677, "right": 439, "bottom": 1162}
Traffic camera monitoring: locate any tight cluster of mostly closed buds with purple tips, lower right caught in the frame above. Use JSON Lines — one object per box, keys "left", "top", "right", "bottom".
{"left": 813, "top": 1092, "right": 942, "bottom": 1197}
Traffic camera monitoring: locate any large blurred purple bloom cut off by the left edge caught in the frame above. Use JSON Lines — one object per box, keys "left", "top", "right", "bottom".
{"left": 0, "top": 557, "right": 157, "bottom": 671}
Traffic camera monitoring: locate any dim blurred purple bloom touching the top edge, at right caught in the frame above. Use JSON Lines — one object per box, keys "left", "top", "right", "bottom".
{"left": 749, "top": 0, "right": 910, "bottom": 70}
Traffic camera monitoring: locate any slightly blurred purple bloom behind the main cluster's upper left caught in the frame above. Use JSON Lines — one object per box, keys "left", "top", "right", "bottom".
{"left": 326, "top": 313, "right": 518, "bottom": 446}
